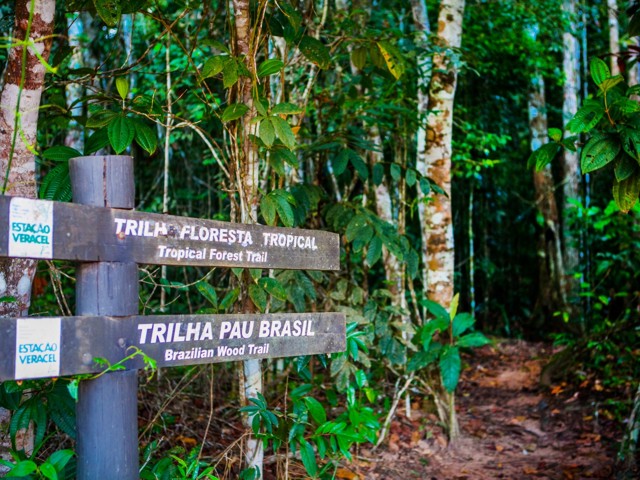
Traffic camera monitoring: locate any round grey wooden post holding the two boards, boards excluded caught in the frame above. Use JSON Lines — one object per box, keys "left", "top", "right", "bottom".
{"left": 70, "top": 156, "right": 139, "bottom": 480}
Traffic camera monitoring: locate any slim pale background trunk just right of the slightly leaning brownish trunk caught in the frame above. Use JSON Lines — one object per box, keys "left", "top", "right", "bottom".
{"left": 562, "top": 0, "right": 580, "bottom": 308}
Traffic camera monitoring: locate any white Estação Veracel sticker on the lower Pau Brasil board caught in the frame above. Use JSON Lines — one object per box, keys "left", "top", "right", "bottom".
{"left": 15, "top": 318, "right": 60, "bottom": 379}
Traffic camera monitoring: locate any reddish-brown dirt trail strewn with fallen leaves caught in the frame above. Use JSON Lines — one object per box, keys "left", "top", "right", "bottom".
{"left": 352, "top": 341, "right": 616, "bottom": 480}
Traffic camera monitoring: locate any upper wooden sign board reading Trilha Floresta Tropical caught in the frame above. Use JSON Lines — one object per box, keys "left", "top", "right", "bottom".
{"left": 0, "top": 196, "right": 340, "bottom": 270}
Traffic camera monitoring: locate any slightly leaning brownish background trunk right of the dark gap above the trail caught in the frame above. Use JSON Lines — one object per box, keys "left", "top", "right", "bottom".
{"left": 529, "top": 74, "right": 566, "bottom": 315}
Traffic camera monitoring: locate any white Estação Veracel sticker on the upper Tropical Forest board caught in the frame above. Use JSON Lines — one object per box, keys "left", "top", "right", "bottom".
{"left": 9, "top": 198, "right": 53, "bottom": 258}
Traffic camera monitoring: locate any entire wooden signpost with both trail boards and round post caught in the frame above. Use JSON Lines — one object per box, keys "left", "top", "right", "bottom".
{"left": 0, "top": 156, "right": 346, "bottom": 480}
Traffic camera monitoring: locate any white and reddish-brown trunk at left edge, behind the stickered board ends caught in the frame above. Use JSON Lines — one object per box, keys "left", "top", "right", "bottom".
{"left": 0, "top": 0, "right": 55, "bottom": 464}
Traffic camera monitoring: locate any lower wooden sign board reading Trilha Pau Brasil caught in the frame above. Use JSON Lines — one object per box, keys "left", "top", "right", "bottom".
{"left": 0, "top": 313, "right": 346, "bottom": 381}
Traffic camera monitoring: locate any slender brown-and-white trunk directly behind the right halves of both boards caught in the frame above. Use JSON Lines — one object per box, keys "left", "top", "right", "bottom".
{"left": 233, "top": 0, "right": 264, "bottom": 478}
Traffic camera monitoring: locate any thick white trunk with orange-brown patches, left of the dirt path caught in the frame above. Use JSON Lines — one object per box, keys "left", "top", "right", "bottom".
{"left": 422, "top": 0, "right": 464, "bottom": 308}
